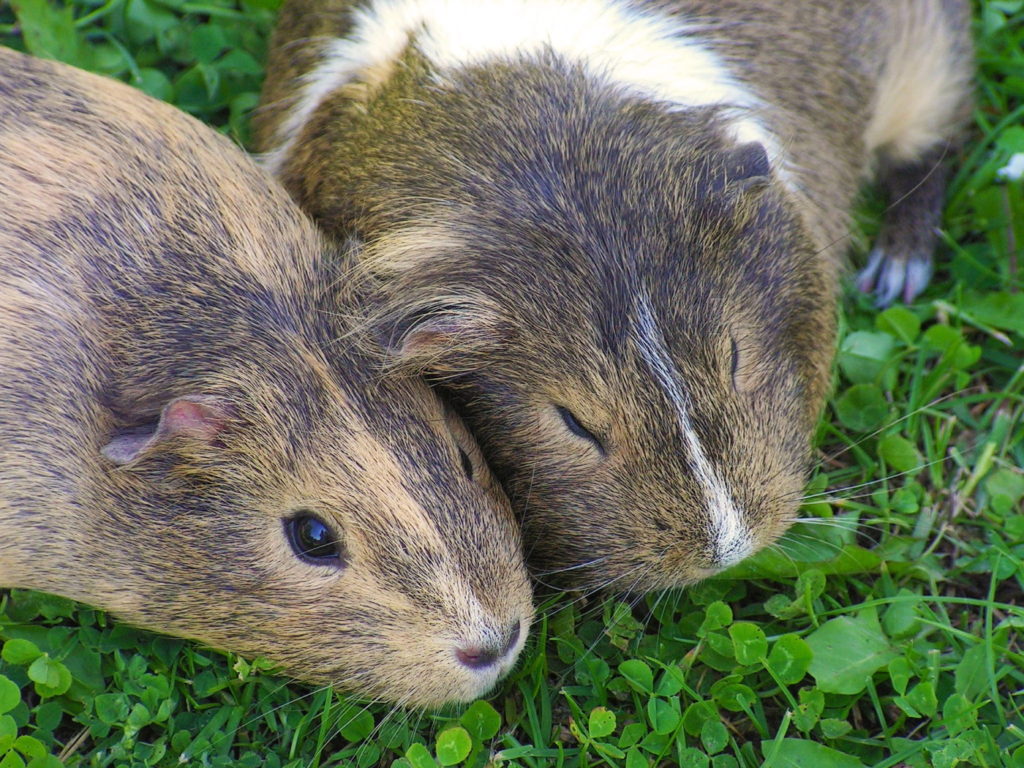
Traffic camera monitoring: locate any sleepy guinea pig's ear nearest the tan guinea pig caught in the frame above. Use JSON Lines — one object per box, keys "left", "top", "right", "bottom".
{"left": 385, "top": 303, "right": 499, "bottom": 372}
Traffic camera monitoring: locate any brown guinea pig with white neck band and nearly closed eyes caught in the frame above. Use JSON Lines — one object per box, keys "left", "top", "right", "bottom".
{"left": 255, "top": 0, "right": 971, "bottom": 591}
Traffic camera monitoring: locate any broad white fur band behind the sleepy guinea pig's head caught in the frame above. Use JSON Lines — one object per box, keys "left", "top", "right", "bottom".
{"left": 264, "top": 0, "right": 785, "bottom": 178}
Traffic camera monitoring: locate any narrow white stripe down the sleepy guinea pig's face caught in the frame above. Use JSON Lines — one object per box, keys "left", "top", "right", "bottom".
{"left": 636, "top": 295, "right": 753, "bottom": 566}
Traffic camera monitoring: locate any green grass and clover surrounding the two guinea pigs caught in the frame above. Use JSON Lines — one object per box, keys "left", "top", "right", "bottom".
{"left": 0, "top": 0, "right": 1024, "bottom": 768}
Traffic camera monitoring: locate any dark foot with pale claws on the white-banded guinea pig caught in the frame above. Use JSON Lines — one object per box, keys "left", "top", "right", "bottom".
{"left": 856, "top": 152, "right": 946, "bottom": 307}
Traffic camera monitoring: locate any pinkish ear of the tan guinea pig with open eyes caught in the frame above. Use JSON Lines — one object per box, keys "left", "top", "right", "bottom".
{"left": 99, "top": 394, "right": 230, "bottom": 466}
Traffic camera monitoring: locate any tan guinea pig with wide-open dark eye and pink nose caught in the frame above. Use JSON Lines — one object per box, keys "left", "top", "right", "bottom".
{"left": 0, "top": 48, "right": 532, "bottom": 707}
